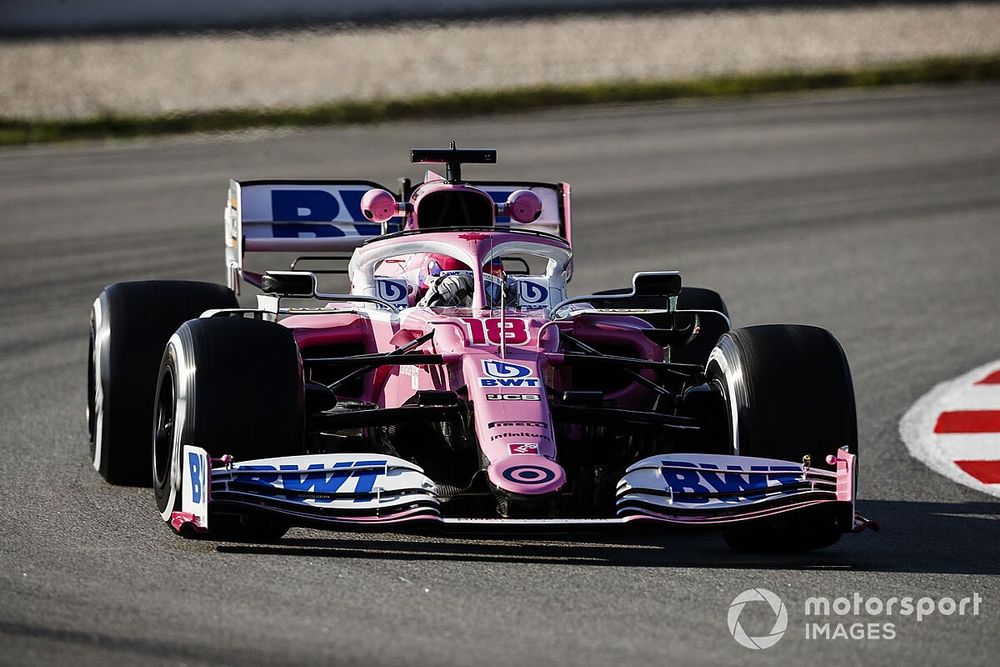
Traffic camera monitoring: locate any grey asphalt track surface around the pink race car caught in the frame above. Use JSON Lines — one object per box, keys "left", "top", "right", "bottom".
{"left": 0, "top": 86, "right": 1000, "bottom": 665}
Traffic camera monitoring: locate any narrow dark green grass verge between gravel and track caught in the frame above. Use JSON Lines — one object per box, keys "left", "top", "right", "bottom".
{"left": 0, "top": 54, "right": 1000, "bottom": 145}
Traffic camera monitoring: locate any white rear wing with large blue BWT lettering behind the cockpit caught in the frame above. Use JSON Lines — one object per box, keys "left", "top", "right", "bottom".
{"left": 225, "top": 180, "right": 571, "bottom": 293}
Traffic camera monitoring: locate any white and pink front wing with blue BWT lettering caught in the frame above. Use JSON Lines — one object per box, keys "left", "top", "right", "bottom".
{"left": 170, "top": 446, "right": 869, "bottom": 532}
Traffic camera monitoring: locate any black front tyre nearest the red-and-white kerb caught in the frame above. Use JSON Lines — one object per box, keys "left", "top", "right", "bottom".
{"left": 706, "top": 325, "right": 858, "bottom": 551}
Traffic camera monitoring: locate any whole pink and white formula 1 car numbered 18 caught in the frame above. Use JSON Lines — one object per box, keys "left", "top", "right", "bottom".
{"left": 88, "top": 145, "right": 880, "bottom": 550}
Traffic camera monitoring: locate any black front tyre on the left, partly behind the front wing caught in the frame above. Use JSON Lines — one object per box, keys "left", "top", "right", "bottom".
{"left": 152, "top": 317, "right": 304, "bottom": 540}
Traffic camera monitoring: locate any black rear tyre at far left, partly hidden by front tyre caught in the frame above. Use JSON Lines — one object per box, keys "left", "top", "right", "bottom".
{"left": 87, "top": 280, "right": 239, "bottom": 486}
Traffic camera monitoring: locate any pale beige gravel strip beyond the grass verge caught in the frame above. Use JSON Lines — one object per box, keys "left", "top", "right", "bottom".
{"left": 0, "top": 3, "right": 1000, "bottom": 120}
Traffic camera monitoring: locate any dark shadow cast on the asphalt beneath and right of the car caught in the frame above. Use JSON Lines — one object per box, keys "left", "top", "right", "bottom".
{"left": 217, "top": 500, "right": 1000, "bottom": 574}
